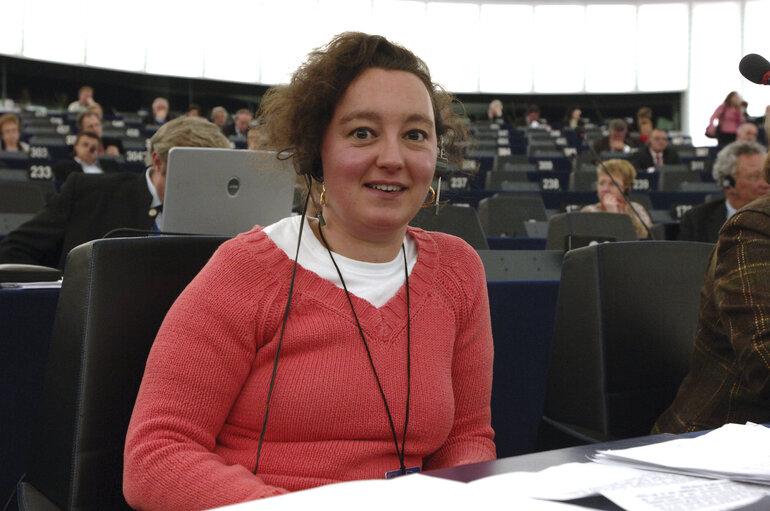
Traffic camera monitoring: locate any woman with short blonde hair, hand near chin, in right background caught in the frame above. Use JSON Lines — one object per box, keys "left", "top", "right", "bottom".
{"left": 580, "top": 159, "right": 652, "bottom": 238}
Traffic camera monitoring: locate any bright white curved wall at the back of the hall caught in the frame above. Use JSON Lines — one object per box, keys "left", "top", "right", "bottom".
{"left": 0, "top": 0, "right": 770, "bottom": 143}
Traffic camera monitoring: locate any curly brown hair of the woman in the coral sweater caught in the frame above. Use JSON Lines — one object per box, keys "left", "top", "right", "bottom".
{"left": 258, "top": 32, "right": 467, "bottom": 181}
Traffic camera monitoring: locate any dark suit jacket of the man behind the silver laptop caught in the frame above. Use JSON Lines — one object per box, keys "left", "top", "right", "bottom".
{"left": 0, "top": 172, "right": 153, "bottom": 268}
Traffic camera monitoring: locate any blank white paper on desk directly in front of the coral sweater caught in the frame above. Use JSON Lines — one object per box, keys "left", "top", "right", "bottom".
{"left": 207, "top": 474, "right": 576, "bottom": 511}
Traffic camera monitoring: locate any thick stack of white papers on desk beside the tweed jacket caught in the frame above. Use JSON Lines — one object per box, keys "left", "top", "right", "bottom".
{"left": 594, "top": 423, "right": 770, "bottom": 484}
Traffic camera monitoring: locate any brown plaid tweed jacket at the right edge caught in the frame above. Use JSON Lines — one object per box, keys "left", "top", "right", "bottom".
{"left": 653, "top": 196, "right": 770, "bottom": 433}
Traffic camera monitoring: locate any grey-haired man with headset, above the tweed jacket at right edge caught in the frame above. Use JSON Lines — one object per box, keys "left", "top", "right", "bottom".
{"left": 679, "top": 141, "right": 770, "bottom": 243}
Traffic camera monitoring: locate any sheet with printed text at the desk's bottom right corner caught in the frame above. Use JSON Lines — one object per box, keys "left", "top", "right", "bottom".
{"left": 602, "top": 478, "right": 768, "bottom": 511}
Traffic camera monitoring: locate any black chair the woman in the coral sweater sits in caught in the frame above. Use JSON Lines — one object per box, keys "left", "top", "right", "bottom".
{"left": 17, "top": 236, "right": 227, "bottom": 511}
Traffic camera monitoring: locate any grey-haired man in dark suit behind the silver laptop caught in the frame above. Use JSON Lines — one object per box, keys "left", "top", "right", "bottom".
{"left": 0, "top": 116, "right": 230, "bottom": 268}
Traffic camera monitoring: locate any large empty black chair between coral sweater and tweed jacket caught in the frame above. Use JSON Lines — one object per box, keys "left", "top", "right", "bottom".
{"left": 539, "top": 241, "right": 713, "bottom": 449}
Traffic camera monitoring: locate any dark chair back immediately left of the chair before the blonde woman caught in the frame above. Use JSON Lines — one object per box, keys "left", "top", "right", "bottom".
{"left": 479, "top": 196, "right": 548, "bottom": 236}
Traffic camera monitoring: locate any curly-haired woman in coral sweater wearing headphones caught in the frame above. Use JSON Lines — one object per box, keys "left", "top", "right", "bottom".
{"left": 124, "top": 33, "right": 495, "bottom": 510}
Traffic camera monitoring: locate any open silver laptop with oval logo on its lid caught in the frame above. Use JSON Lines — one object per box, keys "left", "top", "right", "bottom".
{"left": 163, "top": 147, "right": 295, "bottom": 236}
